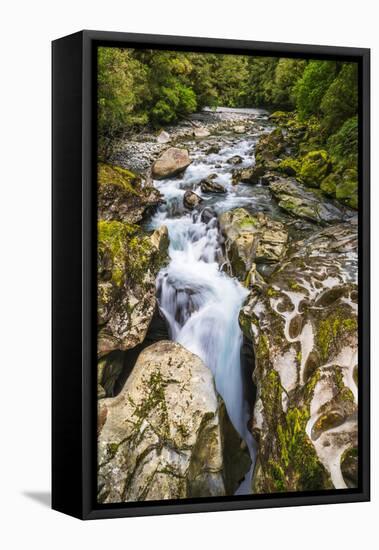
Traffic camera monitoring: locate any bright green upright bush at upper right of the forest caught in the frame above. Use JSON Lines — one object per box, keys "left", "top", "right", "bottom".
{"left": 294, "top": 61, "right": 337, "bottom": 120}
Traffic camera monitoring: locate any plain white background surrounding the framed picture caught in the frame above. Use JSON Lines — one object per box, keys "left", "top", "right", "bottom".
{"left": 0, "top": 0, "right": 379, "bottom": 550}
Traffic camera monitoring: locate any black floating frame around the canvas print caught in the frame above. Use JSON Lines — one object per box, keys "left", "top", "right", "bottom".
{"left": 52, "top": 30, "right": 370, "bottom": 519}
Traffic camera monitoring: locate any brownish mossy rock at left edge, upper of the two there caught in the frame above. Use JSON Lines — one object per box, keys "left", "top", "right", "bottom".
{"left": 97, "top": 163, "right": 162, "bottom": 223}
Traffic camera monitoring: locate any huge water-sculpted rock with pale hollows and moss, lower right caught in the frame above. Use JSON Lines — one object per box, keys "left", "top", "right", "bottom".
{"left": 240, "top": 220, "right": 358, "bottom": 493}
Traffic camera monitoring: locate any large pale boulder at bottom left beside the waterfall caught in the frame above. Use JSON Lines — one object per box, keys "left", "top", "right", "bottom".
{"left": 98, "top": 341, "right": 251, "bottom": 503}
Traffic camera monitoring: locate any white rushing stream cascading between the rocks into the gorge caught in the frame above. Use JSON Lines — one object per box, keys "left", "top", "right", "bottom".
{"left": 149, "top": 109, "right": 272, "bottom": 494}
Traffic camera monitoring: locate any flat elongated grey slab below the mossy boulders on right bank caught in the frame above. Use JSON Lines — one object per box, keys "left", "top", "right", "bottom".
{"left": 269, "top": 178, "right": 350, "bottom": 224}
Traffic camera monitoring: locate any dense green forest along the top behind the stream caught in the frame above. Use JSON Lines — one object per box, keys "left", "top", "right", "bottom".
{"left": 98, "top": 48, "right": 358, "bottom": 207}
